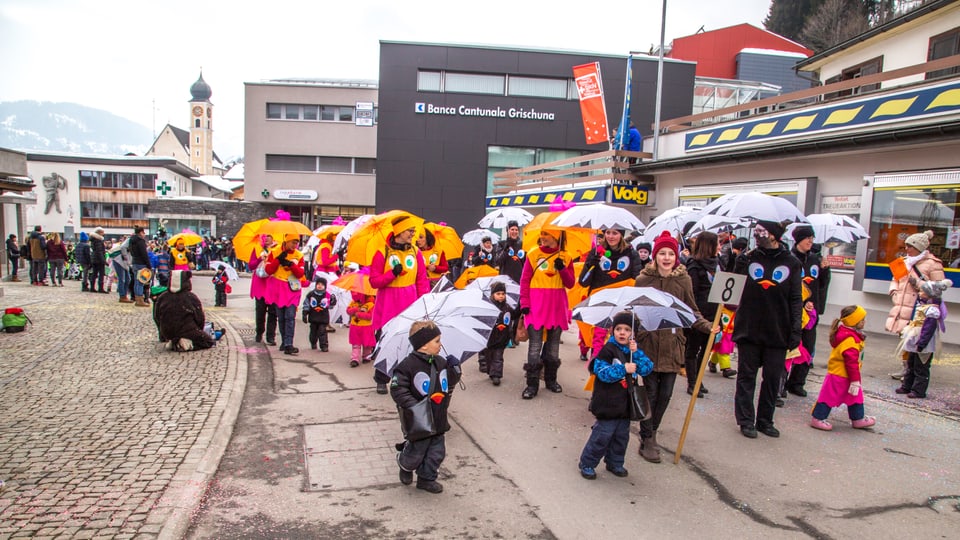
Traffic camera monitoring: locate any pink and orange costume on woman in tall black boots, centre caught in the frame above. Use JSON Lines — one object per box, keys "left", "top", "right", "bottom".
{"left": 520, "top": 248, "right": 577, "bottom": 330}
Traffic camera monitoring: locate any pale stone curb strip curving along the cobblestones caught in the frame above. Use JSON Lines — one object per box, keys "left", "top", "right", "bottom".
{"left": 156, "top": 316, "right": 247, "bottom": 540}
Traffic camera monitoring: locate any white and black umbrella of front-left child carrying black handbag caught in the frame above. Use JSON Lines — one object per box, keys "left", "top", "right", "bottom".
{"left": 373, "top": 289, "right": 500, "bottom": 375}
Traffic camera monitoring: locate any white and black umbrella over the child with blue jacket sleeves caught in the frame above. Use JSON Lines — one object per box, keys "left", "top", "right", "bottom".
{"left": 573, "top": 287, "right": 697, "bottom": 331}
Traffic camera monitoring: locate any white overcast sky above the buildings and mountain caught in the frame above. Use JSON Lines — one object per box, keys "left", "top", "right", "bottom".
{"left": 0, "top": 0, "right": 770, "bottom": 159}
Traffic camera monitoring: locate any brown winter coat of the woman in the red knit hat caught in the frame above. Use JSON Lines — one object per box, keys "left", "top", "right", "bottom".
{"left": 635, "top": 264, "right": 712, "bottom": 373}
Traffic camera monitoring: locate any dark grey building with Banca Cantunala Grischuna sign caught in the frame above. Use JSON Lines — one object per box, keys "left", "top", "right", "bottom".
{"left": 376, "top": 41, "right": 696, "bottom": 231}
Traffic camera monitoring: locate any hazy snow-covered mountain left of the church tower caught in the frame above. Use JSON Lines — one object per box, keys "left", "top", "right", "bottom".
{"left": 0, "top": 101, "right": 153, "bottom": 155}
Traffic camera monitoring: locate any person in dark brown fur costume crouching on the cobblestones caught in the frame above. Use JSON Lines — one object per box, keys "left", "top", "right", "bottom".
{"left": 153, "top": 270, "right": 216, "bottom": 352}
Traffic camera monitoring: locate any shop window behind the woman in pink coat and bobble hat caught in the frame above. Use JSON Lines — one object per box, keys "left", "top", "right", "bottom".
{"left": 867, "top": 184, "right": 960, "bottom": 268}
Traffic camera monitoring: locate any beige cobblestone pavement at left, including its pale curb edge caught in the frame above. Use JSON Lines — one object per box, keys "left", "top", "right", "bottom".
{"left": 0, "top": 281, "right": 246, "bottom": 538}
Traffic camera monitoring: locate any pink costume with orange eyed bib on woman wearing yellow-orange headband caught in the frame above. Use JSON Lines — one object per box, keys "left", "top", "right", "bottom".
{"left": 370, "top": 243, "right": 430, "bottom": 332}
